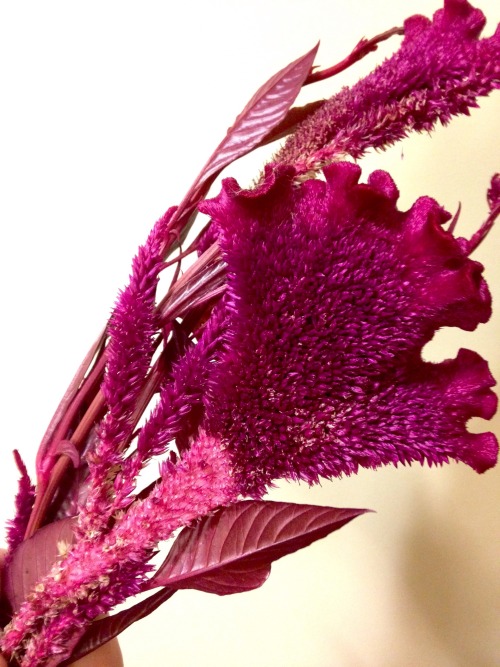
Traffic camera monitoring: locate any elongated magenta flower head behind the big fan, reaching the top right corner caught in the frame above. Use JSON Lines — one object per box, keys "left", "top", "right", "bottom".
{"left": 276, "top": 0, "right": 500, "bottom": 172}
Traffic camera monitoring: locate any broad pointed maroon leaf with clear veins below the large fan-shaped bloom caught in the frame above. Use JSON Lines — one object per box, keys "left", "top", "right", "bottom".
{"left": 149, "top": 500, "right": 366, "bottom": 595}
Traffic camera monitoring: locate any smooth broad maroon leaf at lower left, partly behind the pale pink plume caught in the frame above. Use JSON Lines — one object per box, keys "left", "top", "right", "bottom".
{"left": 4, "top": 519, "right": 75, "bottom": 611}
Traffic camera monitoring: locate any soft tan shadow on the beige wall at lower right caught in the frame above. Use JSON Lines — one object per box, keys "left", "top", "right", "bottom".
{"left": 401, "top": 420, "right": 500, "bottom": 667}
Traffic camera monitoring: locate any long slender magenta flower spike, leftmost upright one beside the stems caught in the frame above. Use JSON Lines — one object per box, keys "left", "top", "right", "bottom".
{"left": 79, "top": 208, "right": 175, "bottom": 531}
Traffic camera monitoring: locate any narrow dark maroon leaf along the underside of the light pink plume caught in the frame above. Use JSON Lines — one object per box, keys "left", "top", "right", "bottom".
{"left": 62, "top": 588, "right": 175, "bottom": 665}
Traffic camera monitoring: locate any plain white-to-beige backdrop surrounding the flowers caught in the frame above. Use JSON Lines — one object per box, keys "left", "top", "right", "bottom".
{"left": 0, "top": 0, "right": 500, "bottom": 667}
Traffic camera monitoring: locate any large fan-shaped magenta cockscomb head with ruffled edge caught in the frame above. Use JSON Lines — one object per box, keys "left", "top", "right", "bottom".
{"left": 203, "top": 162, "right": 497, "bottom": 495}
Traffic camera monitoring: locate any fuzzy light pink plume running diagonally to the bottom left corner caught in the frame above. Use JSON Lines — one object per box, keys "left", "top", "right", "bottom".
{"left": 3, "top": 433, "right": 238, "bottom": 667}
